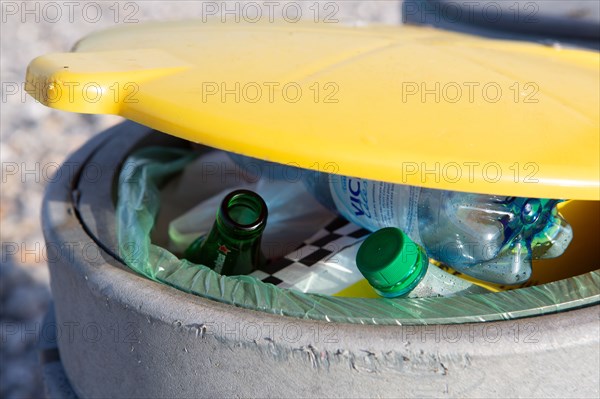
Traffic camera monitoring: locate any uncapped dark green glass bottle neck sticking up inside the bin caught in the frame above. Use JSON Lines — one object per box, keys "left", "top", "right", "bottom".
{"left": 184, "top": 190, "right": 268, "bottom": 276}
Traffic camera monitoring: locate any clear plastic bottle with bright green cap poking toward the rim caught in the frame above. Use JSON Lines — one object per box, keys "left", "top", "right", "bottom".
{"left": 356, "top": 227, "right": 490, "bottom": 298}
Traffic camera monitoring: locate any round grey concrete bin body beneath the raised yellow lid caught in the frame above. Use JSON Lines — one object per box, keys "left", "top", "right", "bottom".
{"left": 43, "top": 122, "right": 600, "bottom": 398}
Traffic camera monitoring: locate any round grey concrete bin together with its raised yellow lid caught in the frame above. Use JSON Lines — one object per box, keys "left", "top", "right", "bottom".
{"left": 28, "top": 20, "right": 600, "bottom": 397}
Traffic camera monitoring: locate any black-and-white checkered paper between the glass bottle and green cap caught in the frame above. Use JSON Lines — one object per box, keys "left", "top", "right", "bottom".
{"left": 251, "top": 217, "right": 370, "bottom": 295}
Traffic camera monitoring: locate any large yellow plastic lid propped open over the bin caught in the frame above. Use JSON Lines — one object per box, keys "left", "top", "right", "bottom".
{"left": 27, "top": 21, "right": 600, "bottom": 200}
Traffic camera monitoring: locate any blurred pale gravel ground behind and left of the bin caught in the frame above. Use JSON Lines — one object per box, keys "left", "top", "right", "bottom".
{"left": 0, "top": 0, "right": 598, "bottom": 398}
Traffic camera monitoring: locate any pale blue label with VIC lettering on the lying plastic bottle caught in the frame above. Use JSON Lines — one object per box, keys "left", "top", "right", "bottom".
{"left": 330, "top": 179, "right": 421, "bottom": 242}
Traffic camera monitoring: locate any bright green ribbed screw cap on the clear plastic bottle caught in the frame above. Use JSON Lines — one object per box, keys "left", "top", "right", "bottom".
{"left": 356, "top": 227, "right": 428, "bottom": 297}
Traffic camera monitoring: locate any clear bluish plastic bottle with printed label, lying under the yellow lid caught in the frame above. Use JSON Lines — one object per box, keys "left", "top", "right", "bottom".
{"left": 326, "top": 175, "right": 573, "bottom": 285}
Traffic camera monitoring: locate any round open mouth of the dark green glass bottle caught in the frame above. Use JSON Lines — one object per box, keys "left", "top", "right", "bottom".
{"left": 219, "top": 190, "right": 268, "bottom": 233}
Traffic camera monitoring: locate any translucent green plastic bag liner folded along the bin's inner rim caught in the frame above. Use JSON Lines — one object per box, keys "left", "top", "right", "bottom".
{"left": 117, "top": 147, "right": 600, "bottom": 325}
